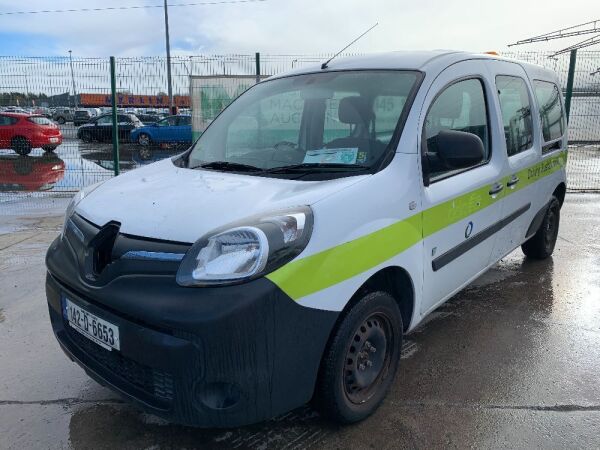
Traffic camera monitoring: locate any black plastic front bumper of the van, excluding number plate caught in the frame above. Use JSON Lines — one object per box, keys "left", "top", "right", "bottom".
{"left": 46, "top": 234, "right": 338, "bottom": 427}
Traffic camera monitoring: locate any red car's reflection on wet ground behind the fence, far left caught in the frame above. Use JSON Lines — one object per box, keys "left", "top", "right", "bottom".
{"left": 0, "top": 153, "right": 65, "bottom": 192}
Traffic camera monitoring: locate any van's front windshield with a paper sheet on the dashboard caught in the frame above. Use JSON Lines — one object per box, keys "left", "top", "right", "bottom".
{"left": 185, "top": 70, "right": 420, "bottom": 179}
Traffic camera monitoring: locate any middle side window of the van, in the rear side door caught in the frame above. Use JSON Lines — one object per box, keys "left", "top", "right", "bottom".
{"left": 496, "top": 75, "right": 533, "bottom": 156}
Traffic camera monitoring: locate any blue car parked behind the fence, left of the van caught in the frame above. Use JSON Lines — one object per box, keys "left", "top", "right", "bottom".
{"left": 131, "top": 115, "right": 192, "bottom": 147}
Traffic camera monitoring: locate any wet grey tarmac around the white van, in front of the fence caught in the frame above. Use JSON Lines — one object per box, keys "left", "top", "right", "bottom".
{"left": 0, "top": 194, "right": 600, "bottom": 449}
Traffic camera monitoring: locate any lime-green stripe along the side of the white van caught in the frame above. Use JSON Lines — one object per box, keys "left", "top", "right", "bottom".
{"left": 267, "top": 151, "right": 567, "bottom": 300}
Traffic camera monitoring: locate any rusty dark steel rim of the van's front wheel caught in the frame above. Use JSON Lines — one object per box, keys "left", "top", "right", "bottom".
{"left": 342, "top": 312, "right": 394, "bottom": 404}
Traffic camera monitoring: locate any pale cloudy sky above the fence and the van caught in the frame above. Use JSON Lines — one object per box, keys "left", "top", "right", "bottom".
{"left": 0, "top": 0, "right": 600, "bottom": 57}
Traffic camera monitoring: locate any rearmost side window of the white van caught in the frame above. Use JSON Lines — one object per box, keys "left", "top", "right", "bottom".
{"left": 533, "top": 80, "right": 565, "bottom": 149}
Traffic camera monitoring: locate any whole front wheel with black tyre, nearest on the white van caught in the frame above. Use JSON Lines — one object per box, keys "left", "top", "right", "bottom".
{"left": 314, "top": 292, "right": 403, "bottom": 423}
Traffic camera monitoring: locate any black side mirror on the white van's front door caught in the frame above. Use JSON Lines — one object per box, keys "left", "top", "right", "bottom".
{"left": 437, "top": 130, "right": 484, "bottom": 169}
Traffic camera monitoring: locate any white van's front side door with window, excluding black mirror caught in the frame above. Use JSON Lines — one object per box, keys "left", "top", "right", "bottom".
{"left": 419, "top": 60, "right": 505, "bottom": 314}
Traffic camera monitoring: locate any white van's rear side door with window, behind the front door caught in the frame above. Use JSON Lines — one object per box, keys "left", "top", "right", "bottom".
{"left": 487, "top": 61, "right": 543, "bottom": 262}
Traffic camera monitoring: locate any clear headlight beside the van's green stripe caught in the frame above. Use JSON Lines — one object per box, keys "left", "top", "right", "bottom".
{"left": 177, "top": 206, "right": 313, "bottom": 286}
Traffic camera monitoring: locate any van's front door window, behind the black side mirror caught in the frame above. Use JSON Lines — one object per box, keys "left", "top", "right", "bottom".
{"left": 423, "top": 78, "right": 490, "bottom": 181}
